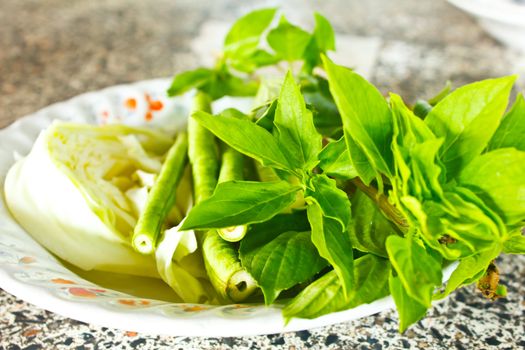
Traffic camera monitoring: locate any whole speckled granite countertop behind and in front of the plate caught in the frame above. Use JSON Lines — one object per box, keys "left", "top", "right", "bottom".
{"left": 0, "top": 0, "right": 525, "bottom": 350}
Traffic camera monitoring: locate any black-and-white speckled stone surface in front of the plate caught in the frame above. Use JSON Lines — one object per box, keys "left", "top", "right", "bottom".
{"left": 0, "top": 256, "right": 525, "bottom": 350}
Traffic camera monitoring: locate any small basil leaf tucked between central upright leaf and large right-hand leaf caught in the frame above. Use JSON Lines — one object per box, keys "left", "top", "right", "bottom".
{"left": 319, "top": 138, "right": 358, "bottom": 180}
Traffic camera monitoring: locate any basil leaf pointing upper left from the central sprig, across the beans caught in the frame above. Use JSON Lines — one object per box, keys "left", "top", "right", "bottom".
{"left": 192, "top": 111, "right": 291, "bottom": 170}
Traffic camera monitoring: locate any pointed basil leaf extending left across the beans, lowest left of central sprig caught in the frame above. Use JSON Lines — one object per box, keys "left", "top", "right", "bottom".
{"left": 181, "top": 181, "right": 301, "bottom": 231}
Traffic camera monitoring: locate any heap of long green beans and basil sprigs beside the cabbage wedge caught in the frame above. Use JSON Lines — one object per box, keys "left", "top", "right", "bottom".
{"left": 6, "top": 9, "right": 525, "bottom": 331}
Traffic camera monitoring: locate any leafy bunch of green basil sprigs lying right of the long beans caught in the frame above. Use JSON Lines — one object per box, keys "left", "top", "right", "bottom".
{"left": 166, "top": 10, "right": 525, "bottom": 331}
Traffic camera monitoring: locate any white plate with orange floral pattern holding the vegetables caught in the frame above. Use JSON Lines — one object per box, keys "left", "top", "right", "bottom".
{"left": 0, "top": 79, "right": 452, "bottom": 336}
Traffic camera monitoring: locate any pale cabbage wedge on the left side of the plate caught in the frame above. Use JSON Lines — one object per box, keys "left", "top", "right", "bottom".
{"left": 5, "top": 122, "right": 173, "bottom": 277}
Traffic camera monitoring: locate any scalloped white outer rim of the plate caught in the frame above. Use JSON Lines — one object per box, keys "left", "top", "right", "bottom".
{"left": 0, "top": 78, "right": 457, "bottom": 337}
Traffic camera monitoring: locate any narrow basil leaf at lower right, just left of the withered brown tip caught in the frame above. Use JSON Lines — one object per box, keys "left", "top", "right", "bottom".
{"left": 435, "top": 245, "right": 501, "bottom": 299}
